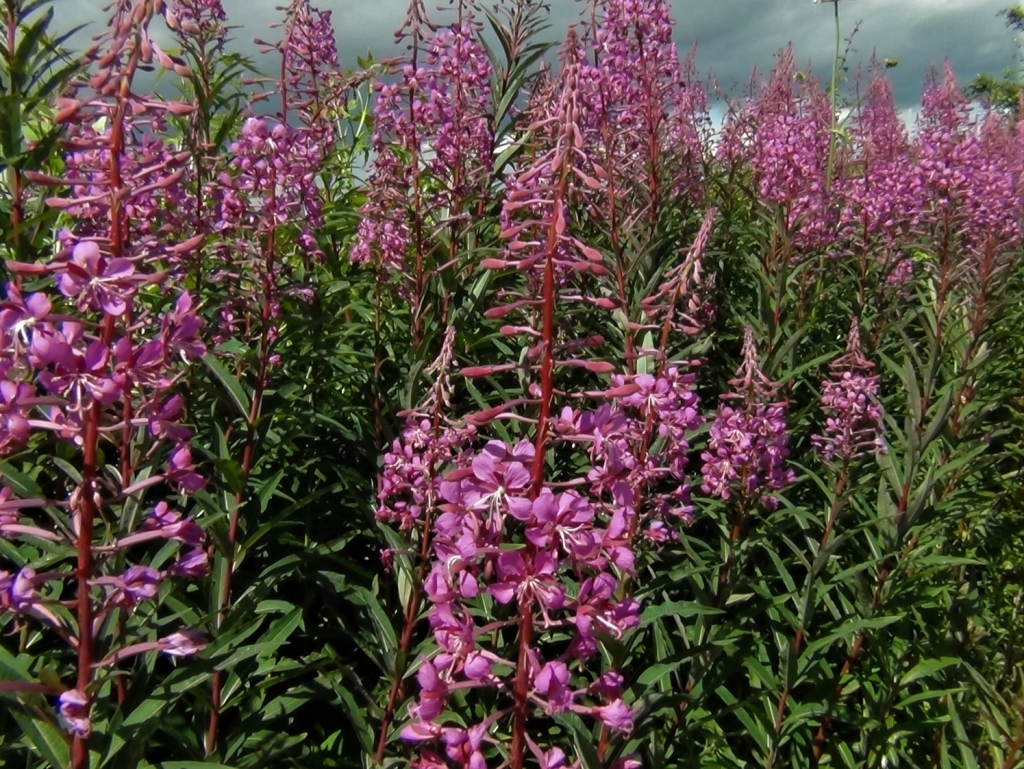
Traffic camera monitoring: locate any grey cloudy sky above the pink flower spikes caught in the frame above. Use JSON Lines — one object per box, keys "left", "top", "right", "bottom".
{"left": 51, "top": 0, "right": 1017, "bottom": 112}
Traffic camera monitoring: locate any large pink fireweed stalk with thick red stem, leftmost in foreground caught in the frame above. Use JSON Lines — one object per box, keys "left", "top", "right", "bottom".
{"left": 0, "top": 0, "right": 209, "bottom": 769}
